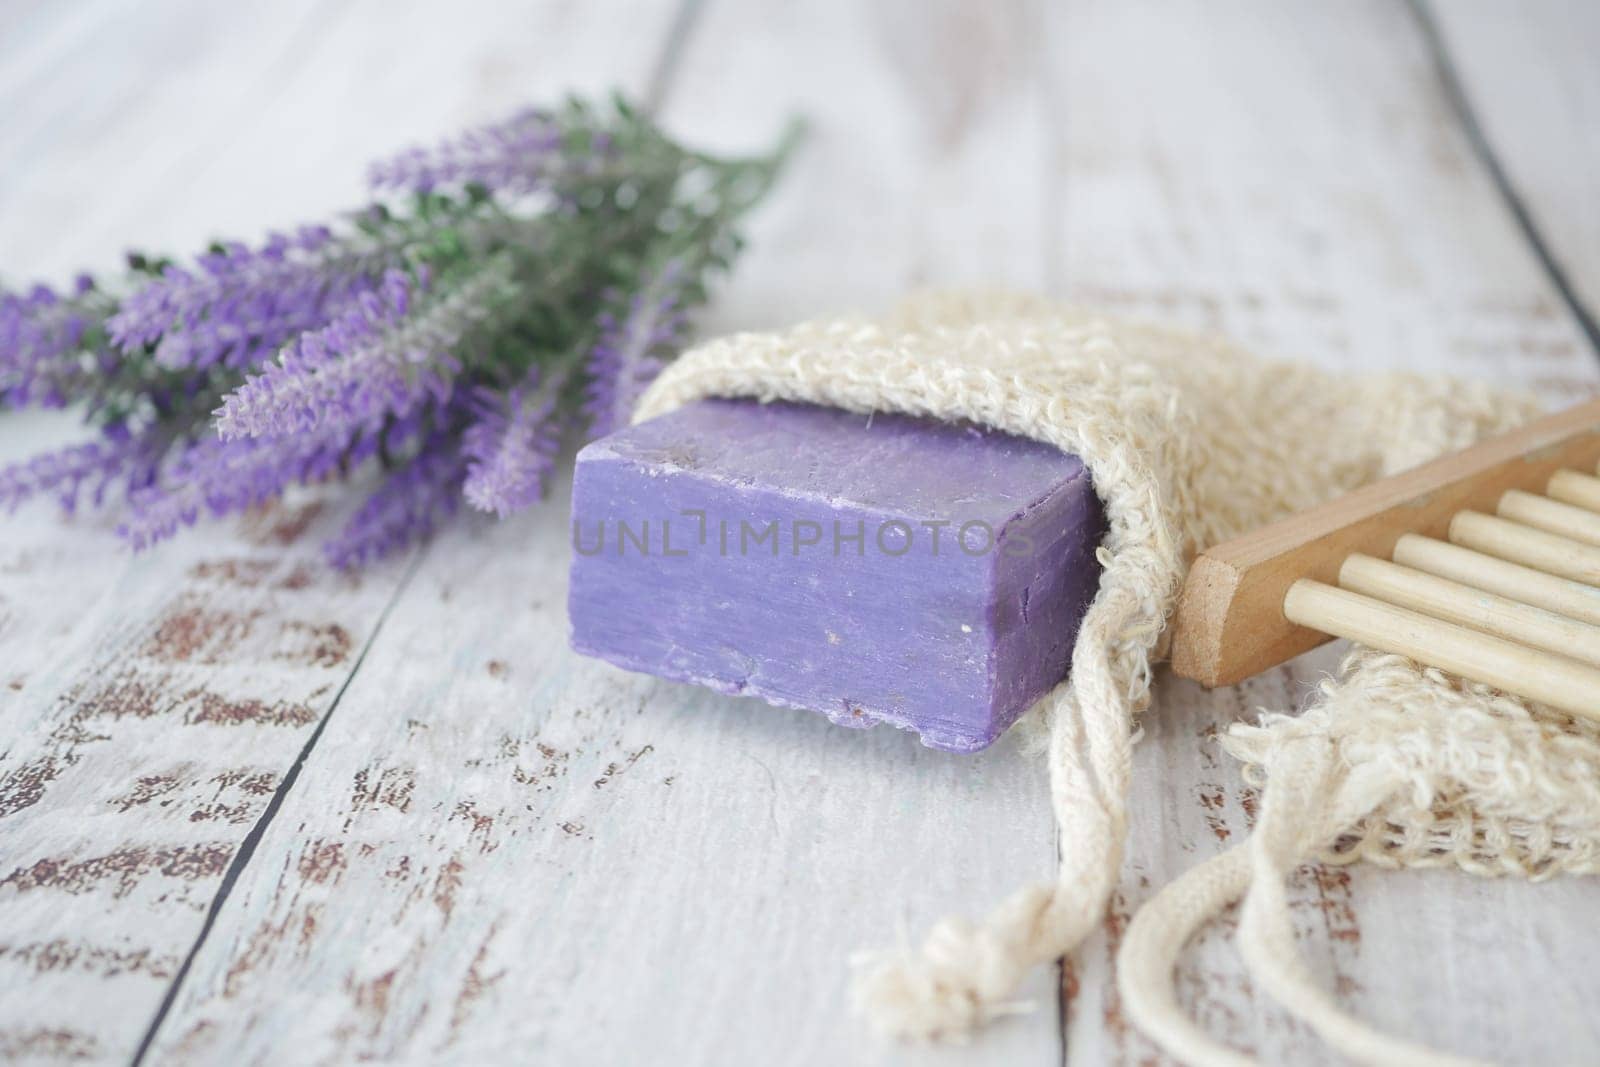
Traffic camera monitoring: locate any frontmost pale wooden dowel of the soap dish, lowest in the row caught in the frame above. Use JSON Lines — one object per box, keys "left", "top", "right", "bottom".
{"left": 1283, "top": 577, "right": 1600, "bottom": 720}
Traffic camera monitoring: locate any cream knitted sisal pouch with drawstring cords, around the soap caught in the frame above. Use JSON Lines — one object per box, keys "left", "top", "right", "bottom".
{"left": 635, "top": 287, "right": 1600, "bottom": 1064}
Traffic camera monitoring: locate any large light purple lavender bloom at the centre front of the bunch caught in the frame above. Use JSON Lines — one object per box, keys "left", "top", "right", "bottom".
{"left": 216, "top": 259, "right": 510, "bottom": 438}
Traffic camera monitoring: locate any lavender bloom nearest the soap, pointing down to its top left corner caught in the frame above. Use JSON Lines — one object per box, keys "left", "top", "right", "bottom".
{"left": 584, "top": 264, "right": 686, "bottom": 438}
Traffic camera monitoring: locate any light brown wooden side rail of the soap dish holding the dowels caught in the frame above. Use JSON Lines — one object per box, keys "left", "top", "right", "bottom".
{"left": 1171, "top": 402, "right": 1600, "bottom": 685}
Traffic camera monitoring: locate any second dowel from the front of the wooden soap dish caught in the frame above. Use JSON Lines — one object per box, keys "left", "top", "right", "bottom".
{"left": 1339, "top": 555, "right": 1600, "bottom": 667}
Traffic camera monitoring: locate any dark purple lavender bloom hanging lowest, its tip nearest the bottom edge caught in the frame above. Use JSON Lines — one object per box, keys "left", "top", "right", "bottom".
{"left": 323, "top": 434, "right": 466, "bottom": 569}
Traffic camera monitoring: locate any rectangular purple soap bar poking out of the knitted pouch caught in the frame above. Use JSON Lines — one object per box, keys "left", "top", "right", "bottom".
{"left": 568, "top": 400, "right": 1106, "bottom": 752}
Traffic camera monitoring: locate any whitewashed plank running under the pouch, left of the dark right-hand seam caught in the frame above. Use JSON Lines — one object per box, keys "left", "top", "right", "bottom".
{"left": 1043, "top": 3, "right": 1600, "bottom": 1064}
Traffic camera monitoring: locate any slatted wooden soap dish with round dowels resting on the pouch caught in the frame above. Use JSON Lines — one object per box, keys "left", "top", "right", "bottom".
{"left": 1171, "top": 400, "right": 1600, "bottom": 718}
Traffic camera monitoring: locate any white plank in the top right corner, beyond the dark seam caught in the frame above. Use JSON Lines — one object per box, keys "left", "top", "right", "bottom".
{"left": 1427, "top": 0, "right": 1600, "bottom": 340}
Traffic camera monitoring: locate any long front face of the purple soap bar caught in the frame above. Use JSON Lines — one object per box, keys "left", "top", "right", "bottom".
{"left": 571, "top": 461, "right": 990, "bottom": 744}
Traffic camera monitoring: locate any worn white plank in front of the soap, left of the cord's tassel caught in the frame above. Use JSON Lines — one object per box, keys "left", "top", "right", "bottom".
{"left": 140, "top": 476, "right": 1054, "bottom": 1064}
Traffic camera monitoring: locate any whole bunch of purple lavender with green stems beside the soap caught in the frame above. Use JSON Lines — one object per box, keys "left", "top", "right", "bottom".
{"left": 0, "top": 101, "right": 795, "bottom": 566}
